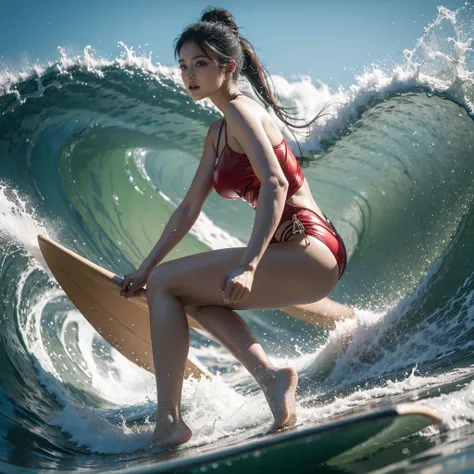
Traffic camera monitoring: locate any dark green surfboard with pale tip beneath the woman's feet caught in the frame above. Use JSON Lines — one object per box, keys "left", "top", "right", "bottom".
{"left": 129, "top": 403, "right": 442, "bottom": 474}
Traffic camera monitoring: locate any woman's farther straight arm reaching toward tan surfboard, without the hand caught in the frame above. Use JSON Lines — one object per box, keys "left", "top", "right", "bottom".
{"left": 140, "top": 122, "right": 217, "bottom": 271}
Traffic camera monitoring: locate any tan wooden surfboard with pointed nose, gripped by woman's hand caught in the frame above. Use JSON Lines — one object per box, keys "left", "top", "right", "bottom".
{"left": 38, "top": 234, "right": 211, "bottom": 378}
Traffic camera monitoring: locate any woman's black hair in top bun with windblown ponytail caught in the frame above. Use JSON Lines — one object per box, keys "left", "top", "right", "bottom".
{"left": 174, "top": 7, "right": 327, "bottom": 159}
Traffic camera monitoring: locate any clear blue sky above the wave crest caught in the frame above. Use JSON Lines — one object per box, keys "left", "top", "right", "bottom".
{"left": 0, "top": 0, "right": 465, "bottom": 87}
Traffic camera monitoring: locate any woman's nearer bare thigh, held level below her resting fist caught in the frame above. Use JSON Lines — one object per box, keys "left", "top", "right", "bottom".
{"left": 147, "top": 237, "right": 339, "bottom": 309}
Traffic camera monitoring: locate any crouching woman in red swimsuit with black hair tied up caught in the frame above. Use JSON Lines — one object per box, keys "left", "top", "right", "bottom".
{"left": 121, "top": 8, "right": 346, "bottom": 447}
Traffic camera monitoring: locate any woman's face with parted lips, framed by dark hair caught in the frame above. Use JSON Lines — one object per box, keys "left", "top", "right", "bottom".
{"left": 179, "top": 41, "right": 225, "bottom": 100}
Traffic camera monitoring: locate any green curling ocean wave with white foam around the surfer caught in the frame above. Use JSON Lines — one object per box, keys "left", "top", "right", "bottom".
{"left": 0, "top": 4, "right": 474, "bottom": 473}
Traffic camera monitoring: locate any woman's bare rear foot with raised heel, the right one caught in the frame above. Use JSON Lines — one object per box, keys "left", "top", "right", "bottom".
{"left": 263, "top": 368, "right": 298, "bottom": 431}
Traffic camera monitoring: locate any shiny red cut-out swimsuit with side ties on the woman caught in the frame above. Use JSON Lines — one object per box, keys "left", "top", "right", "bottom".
{"left": 214, "top": 96, "right": 346, "bottom": 278}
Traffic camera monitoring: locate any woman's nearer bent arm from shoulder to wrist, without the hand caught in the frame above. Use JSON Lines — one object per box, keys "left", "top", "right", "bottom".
{"left": 225, "top": 102, "right": 288, "bottom": 270}
